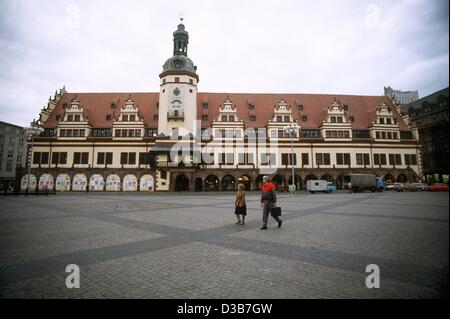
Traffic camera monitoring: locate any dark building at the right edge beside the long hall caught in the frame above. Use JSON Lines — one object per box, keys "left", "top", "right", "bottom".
{"left": 402, "top": 87, "right": 450, "bottom": 184}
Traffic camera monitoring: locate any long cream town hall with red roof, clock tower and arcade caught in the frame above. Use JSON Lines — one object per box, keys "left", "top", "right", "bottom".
{"left": 18, "top": 24, "right": 422, "bottom": 192}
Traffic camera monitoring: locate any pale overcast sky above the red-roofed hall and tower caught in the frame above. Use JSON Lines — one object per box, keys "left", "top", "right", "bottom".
{"left": 0, "top": 0, "right": 449, "bottom": 125}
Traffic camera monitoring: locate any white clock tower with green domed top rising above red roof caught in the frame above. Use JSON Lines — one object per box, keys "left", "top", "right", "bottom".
{"left": 158, "top": 19, "right": 199, "bottom": 136}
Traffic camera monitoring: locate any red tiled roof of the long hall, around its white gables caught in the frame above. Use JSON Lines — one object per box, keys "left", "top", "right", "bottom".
{"left": 44, "top": 93, "right": 408, "bottom": 130}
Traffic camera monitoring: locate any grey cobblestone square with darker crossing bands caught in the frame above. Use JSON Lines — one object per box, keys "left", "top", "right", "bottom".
{"left": 0, "top": 192, "right": 449, "bottom": 299}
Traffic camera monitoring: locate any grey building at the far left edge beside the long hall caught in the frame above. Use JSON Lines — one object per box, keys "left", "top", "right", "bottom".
{"left": 0, "top": 121, "right": 26, "bottom": 189}
